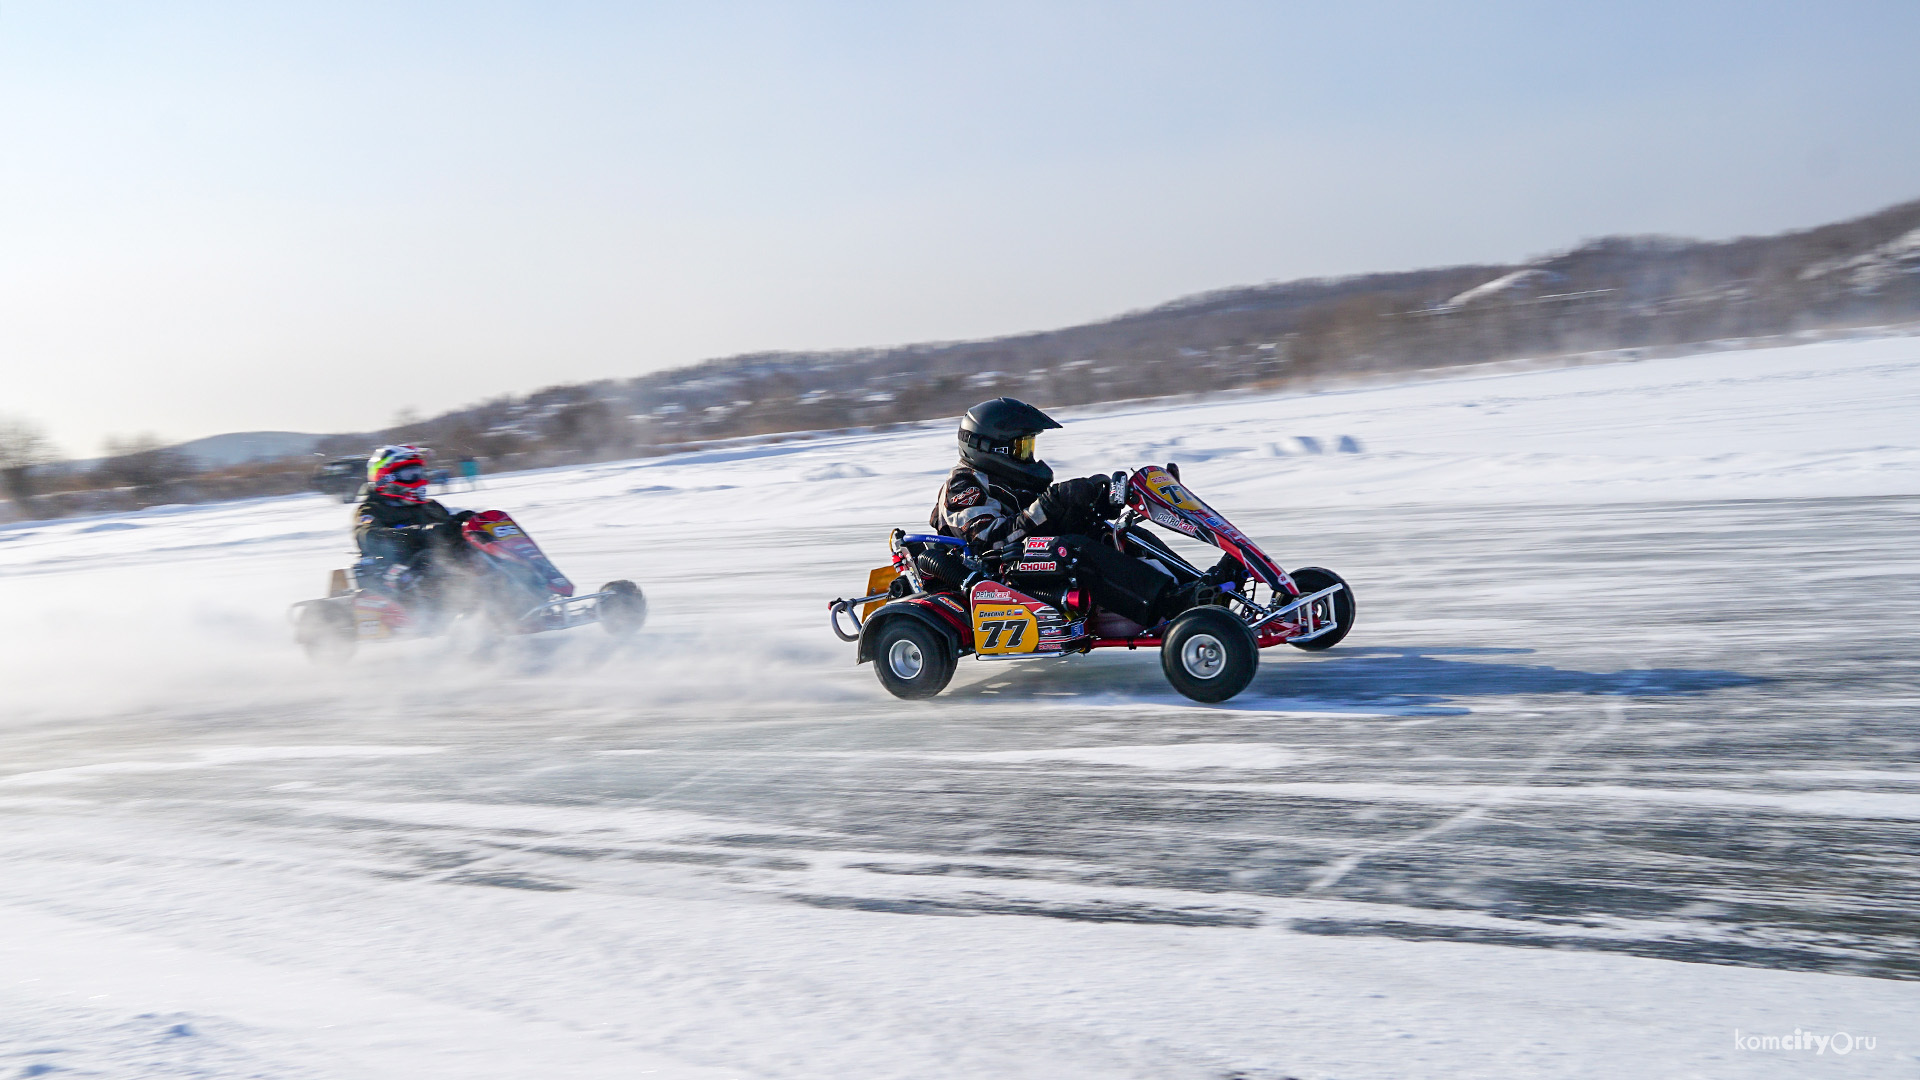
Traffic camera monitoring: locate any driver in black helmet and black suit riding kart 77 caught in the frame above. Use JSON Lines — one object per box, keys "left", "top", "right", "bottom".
{"left": 927, "top": 398, "right": 1246, "bottom": 626}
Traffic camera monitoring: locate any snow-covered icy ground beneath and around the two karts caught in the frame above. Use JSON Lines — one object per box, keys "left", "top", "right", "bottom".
{"left": 0, "top": 338, "right": 1920, "bottom": 1080}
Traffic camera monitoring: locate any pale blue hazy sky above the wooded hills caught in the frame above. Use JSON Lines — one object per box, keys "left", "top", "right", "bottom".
{"left": 0, "top": 0, "right": 1920, "bottom": 455}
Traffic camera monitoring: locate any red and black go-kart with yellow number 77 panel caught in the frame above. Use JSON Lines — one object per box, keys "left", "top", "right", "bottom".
{"left": 828, "top": 465, "right": 1354, "bottom": 701}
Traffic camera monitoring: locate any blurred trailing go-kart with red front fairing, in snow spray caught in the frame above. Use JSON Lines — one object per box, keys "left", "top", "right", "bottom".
{"left": 288, "top": 509, "right": 647, "bottom": 663}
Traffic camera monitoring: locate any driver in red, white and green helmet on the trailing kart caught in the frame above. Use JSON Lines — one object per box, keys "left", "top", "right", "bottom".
{"left": 353, "top": 446, "right": 472, "bottom": 594}
